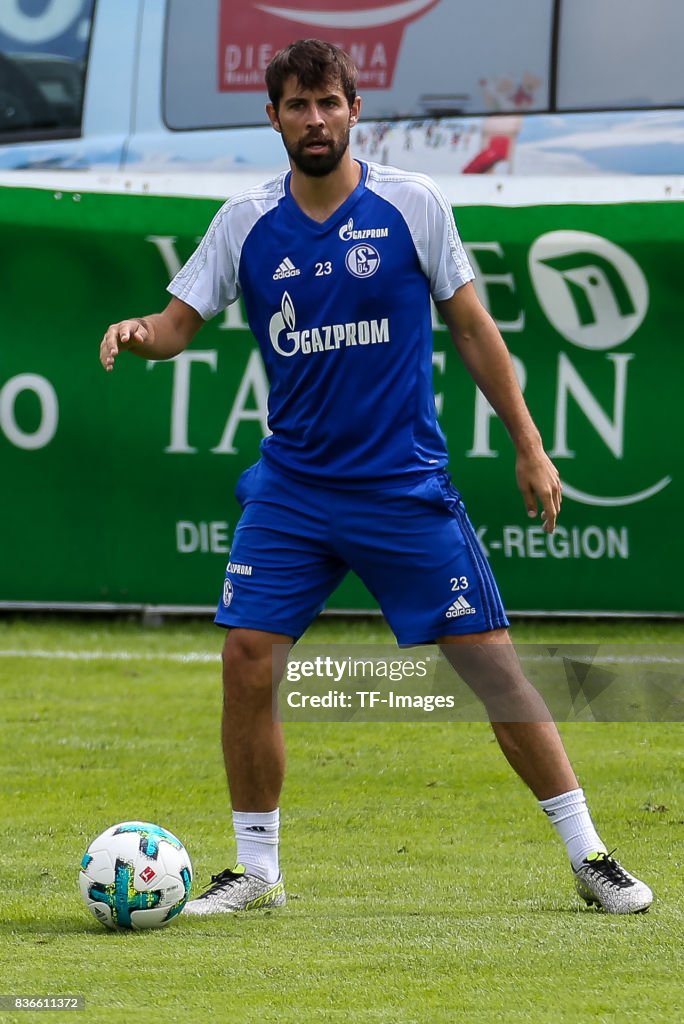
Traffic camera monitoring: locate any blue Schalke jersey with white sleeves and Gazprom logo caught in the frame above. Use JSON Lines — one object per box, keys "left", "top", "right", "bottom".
{"left": 169, "top": 164, "right": 473, "bottom": 486}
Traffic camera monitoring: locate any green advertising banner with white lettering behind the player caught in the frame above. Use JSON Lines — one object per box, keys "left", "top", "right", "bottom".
{"left": 0, "top": 187, "right": 684, "bottom": 613}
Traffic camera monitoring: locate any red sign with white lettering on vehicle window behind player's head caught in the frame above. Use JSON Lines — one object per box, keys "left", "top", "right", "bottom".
{"left": 218, "top": 0, "right": 439, "bottom": 92}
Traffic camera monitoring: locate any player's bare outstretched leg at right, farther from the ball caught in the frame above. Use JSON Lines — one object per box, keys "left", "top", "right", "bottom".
{"left": 437, "top": 630, "right": 580, "bottom": 800}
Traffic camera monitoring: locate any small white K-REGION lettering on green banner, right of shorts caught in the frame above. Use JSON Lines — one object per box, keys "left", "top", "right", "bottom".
{"left": 477, "top": 525, "right": 630, "bottom": 560}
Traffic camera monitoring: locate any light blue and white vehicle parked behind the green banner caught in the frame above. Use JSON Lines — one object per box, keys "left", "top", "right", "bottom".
{"left": 0, "top": 0, "right": 684, "bottom": 176}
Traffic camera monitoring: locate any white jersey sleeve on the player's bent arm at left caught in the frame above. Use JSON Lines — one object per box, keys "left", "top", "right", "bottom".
{"left": 167, "top": 202, "right": 240, "bottom": 321}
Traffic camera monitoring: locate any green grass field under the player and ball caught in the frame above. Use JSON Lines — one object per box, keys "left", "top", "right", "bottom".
{"left": 0, "top": 618, "right": 684, "bottom": 1024}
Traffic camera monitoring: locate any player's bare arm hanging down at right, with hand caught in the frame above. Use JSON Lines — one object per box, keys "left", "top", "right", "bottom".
{"left": 437, "top": 284, "right": 561, "bottom": 534}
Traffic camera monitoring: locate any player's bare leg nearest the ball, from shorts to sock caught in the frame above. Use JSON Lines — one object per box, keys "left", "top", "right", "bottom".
{"left": 222, "top": 629, "right": 292, "bottom": 812}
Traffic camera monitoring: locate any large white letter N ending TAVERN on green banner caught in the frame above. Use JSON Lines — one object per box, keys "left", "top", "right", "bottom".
{"left": 549, "top": 352, "right": 634, "bottom": 459}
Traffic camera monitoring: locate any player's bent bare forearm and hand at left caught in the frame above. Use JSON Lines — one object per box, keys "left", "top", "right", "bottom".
{"left": 99, "top": 298, "right": 204, "bottom": 372}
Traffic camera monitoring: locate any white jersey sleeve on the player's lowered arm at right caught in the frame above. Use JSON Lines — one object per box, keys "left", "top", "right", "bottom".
{"left": 424, "top": 179, "right": 475, "bottom": 302}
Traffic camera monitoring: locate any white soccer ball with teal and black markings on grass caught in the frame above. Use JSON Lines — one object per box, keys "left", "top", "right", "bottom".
{"left": 79, "top": 821, "right": 193, "bottom": 930}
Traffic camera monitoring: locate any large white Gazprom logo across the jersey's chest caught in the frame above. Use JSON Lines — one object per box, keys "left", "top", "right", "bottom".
{"left": 268, "top": 292, "right": 390, "bottom": 357}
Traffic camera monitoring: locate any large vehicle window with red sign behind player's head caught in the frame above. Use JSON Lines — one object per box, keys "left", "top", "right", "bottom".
{"left": 163, "top": 0, "right": 552, "bottom": 130}
